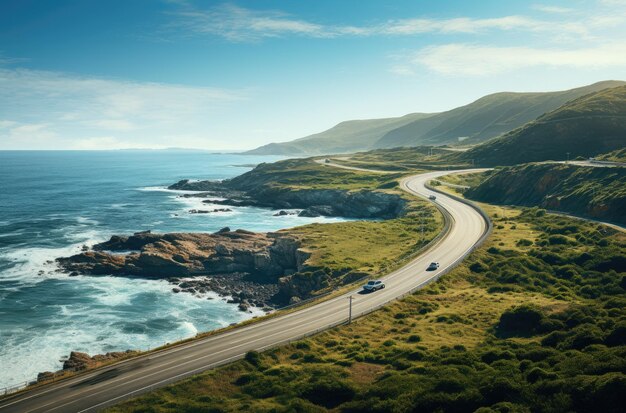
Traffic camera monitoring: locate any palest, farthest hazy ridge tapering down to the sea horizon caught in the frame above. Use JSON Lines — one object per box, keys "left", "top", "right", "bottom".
{"left": 245, "top": 113, "right": 432, "bottom": 155}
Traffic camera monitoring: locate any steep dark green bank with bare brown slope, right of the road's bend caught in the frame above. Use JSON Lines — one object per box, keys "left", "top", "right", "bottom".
{"left": 465, "top": 164, "right": 626, "bottom": 225}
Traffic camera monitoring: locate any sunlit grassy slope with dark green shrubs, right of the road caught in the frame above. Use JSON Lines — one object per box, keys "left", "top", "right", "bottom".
{"left": 108, "top": 208, "right": 626, "bottom": 413}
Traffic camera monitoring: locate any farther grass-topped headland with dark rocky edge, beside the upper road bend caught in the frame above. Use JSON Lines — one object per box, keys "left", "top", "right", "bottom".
{"left": 168, "top": 159, "right": 407, "bottom": 219}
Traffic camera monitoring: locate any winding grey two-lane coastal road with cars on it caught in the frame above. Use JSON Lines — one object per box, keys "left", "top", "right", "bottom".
{"left": 0, "top": 171, "right": 488, "bottom": 413}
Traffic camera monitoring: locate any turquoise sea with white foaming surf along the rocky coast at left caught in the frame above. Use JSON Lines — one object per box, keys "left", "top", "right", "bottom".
{"left": 0, "top": 151, "right": 346, "bottom": 387}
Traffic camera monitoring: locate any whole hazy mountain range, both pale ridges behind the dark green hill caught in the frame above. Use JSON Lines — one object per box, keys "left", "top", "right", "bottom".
{"left": 245, "top": 81, "right": 626, "bottom": 156}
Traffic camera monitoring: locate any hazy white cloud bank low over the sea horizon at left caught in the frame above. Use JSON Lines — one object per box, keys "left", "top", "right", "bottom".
{"left": 0, "top": 68, "right": 247, "bottom": 149}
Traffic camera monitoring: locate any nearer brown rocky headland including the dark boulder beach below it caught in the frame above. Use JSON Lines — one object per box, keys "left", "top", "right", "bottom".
{"left": 56, "top": 228, "right": 310, "bottom": 311}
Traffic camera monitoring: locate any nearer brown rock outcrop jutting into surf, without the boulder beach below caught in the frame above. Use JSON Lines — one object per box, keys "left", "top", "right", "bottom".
{"left": 57, "top": 230, "right": 306, "bottom": 278}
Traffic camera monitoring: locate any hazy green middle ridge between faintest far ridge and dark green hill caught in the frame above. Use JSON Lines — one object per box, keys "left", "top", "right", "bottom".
{"left": 375, "top": 80, "right": 626, "bottom": 148}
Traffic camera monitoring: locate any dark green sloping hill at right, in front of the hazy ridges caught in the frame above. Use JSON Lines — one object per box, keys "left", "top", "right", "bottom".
{"left": 456, "top": 86, "right": 626, "bottom": 165}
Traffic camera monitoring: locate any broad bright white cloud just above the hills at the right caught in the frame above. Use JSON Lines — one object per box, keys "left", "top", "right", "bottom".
{"left": 413, "top": 43, "right": 626, "bottom": 76}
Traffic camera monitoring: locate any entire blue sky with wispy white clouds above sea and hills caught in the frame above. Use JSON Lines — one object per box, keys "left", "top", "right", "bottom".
{"left": 0, "top": 0, "right": 626, "bottom": 150}
